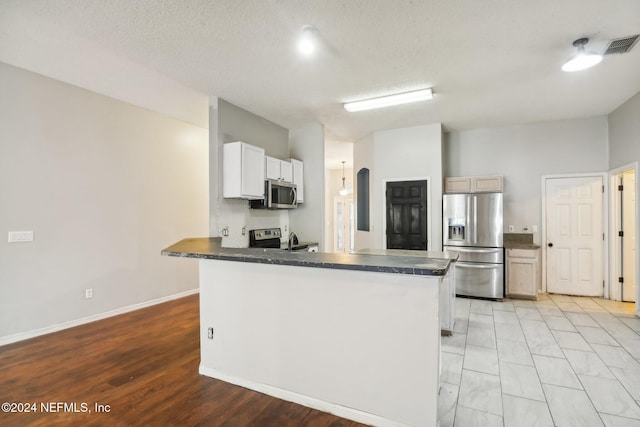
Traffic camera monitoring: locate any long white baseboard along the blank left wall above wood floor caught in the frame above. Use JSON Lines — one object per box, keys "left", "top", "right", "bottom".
{"left": 0, "top": 288, "right": 200, "bottom": 346}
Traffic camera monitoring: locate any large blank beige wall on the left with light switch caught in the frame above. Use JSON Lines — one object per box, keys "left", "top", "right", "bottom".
{"left": 0, "top": 63, "right": 208, "bottom": 342}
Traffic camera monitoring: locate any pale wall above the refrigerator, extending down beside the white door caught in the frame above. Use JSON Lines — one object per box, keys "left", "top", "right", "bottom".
{"left": 444, "top": 116, "right": 608, "bottom": 241}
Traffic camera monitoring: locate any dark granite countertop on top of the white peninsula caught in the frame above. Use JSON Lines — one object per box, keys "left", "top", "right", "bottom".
{"left": 161, "top": 237, "right": 451, "bottom": 276}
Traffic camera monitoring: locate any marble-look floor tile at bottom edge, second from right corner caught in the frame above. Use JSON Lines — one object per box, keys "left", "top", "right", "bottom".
{"left": 542, "top": 384, "right": 604, "bottom": 427}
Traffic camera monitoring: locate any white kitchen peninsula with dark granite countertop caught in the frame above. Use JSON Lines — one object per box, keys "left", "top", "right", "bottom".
{"left": 162, "top": 238, "right": 451, "bottom": 426}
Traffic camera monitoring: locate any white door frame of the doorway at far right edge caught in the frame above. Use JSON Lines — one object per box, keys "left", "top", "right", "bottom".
{"left": 608, "top": 162, "right": 640, "bottom": 310}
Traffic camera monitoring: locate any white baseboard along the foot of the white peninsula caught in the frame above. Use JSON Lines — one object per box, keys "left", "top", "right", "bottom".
{"left": 199, "top": 365, "right": 409, "bottom": 427}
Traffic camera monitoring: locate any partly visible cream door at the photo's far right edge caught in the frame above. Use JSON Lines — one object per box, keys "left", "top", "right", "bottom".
{"left": 622, "top": 170, "right": 636, "bottom": 302}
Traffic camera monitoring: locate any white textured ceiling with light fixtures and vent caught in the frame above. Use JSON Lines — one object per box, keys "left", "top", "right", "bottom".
{"left": 0, "top": 0, "right": 640, "bottom": 168}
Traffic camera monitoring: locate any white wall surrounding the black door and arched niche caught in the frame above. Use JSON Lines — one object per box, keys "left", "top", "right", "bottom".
{"left": 354, "top": 123, "right": 442, "bottom": 250}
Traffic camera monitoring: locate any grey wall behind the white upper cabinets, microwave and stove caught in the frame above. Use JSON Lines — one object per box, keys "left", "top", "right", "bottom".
{"left": 210, "top": 99, "right": 288, "bottom": 247}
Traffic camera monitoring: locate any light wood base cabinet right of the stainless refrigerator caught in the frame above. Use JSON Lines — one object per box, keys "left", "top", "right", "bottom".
{"left": 507, "top": 249, "right": 540, "bottom": 299}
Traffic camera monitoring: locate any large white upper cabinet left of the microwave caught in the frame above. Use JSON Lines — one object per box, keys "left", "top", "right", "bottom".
{"left": 222, "top": 141, "right": 264, "bottom": 199}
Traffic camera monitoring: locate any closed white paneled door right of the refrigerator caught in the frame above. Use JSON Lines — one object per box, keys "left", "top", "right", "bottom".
{"left": 545, "top": 176, "right": 604, "bottom": 296}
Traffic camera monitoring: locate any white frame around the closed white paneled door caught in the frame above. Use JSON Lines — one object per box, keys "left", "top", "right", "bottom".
{"left": 540, "top": 172, "right": 609, "bottom": 298}
